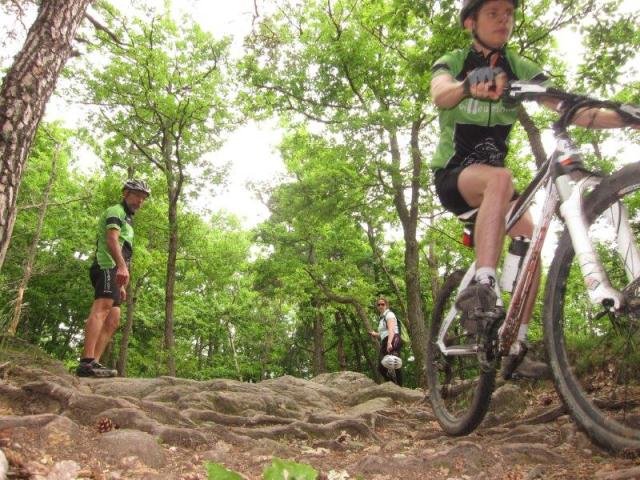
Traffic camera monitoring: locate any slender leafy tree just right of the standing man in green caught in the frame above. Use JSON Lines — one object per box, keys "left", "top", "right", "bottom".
{"left": 73, "top": 5, "right": 238, "bottom": 375}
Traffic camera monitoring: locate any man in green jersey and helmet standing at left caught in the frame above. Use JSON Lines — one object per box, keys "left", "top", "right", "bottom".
{"left": 76, "top": 180, "right": 151, "bottom": 377}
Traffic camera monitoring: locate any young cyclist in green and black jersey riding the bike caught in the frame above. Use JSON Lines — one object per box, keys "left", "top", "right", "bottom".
{"left": 431, "top": 0, "right": 637, "bottom": 376}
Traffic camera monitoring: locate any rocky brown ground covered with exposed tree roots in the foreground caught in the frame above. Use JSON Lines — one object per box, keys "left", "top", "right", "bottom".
{"left": 0, "top": 340, "right": 640, "bottom": 480}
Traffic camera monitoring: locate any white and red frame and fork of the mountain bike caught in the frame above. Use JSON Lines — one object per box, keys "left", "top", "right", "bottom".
{"left": 436, "top": 82, "right": 640, "bottom": 356}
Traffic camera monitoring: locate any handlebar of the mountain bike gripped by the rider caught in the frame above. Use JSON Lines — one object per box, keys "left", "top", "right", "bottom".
{"left": 502, "top": 80, "right": 640, "bottom": 127}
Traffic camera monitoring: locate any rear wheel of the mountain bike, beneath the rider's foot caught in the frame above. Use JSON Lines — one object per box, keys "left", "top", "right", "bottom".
{"left": 427, "top": 271, "right": 496, "bottom": 436}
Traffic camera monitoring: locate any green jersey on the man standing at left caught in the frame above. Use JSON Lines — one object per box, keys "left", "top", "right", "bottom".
{"left": 95, "top": 201, "right": 133, "bottom": 268}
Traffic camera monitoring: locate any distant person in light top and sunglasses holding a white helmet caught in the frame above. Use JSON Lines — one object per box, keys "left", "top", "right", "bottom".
{"left": 369, "top": 297, "right": 402, "bottom": 386}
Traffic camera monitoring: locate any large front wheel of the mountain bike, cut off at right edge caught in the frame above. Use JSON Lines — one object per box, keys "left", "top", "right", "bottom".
{"left": 544, "top": 164, "right": 640, "bottom": 452}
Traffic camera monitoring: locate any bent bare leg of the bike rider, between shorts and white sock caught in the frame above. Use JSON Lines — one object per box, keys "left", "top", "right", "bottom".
{"left": 458, "top": 164, "right": 513, "bottom": 269}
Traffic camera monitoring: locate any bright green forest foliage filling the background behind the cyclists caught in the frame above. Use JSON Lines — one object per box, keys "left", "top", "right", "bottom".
{"left": 5, "top": 0, "right": 640, "bottom": 385}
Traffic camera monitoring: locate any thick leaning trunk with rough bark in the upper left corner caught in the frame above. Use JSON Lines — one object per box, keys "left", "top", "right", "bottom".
{"left": 0, "top": 0, "right": 91, "bottom": 269}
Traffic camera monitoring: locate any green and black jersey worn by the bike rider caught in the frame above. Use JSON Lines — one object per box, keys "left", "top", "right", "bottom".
{"left": 431, "top": 47, "right": 547, "bottom": 170}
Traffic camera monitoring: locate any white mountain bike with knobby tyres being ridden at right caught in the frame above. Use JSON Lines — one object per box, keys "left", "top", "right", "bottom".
{"left": 427, "top": 82, "right": 640, "bottom": 451}
